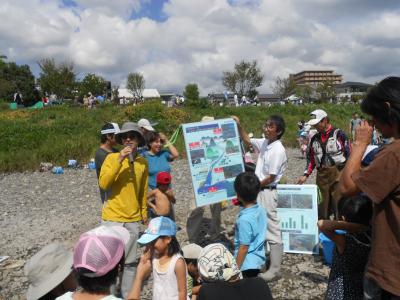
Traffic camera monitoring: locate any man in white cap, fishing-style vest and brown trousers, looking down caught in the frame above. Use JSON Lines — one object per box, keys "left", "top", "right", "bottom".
{"left": 297, "top": 109, "right": 351, "bottom": 219}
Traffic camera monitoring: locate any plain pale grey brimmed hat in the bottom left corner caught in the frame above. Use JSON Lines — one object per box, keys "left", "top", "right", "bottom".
{"left": 24, "top": 243, "right": 73, "bottom": 300}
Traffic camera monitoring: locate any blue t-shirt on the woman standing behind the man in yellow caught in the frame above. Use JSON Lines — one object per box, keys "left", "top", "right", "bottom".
{"left": 143, "top": 150, "right": 171, "bottom": 190}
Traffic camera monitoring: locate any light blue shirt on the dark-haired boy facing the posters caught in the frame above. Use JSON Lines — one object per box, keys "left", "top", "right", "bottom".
{"left": 235, "top": 204, "right": 267, "bottom": 271}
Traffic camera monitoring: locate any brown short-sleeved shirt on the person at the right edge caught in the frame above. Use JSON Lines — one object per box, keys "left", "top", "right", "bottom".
{"left": 352, "top": 140, "right": 400, "bottom": 296}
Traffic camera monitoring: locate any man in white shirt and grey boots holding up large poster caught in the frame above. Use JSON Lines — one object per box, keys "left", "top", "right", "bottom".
{"left": 232, "top": 115, "right": 287, "bottom": 281}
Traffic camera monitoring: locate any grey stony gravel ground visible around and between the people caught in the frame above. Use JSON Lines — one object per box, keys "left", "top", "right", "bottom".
{"left": 0, "top": 149, "right": 329, "bottom": 300}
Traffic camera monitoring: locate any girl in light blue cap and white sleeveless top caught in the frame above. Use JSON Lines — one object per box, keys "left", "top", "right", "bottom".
{"left": 127, "top": 217, "right": 189, "bottom": 300}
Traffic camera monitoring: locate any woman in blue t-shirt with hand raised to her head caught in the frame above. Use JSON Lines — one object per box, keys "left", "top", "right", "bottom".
{"left": 143, "top": 131, "right": 179, "bottom": 190}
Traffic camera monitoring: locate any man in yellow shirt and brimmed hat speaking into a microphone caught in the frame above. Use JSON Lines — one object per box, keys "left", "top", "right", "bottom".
{"left": 99, "top": 122, "right": 149, "bottom": 298}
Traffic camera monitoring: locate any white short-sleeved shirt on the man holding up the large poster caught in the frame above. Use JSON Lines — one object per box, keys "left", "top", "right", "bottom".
{"left": 250, "top": 139, "right": 287, "bottom": 185}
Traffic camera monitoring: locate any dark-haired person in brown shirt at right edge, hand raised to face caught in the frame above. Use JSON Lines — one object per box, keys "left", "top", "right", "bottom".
{"left": 338, "top": 77, "right": 400, "bottom": 299}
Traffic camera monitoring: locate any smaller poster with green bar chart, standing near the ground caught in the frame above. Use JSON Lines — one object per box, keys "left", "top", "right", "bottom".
{"left": 277, "top": 184, "right": 319, "bottom": 254}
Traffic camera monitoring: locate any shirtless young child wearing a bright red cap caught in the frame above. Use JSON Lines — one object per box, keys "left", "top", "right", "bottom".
{"left": 147, "top": 172, "right": 175, "bottom": 221}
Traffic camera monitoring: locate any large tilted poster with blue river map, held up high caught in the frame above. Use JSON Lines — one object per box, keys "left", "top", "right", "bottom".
{"left": 182, "top": 119, "right": 244, "bottom": 206}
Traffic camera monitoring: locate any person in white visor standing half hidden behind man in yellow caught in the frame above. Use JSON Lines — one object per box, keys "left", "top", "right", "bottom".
{"left": 94, "top": 123, "right": 119, "bottom": 203}
